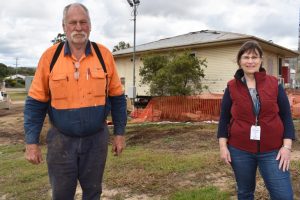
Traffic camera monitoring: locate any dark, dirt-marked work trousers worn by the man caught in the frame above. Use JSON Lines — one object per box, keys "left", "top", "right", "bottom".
{"left": 46, "top": 126, "right": 108, "bottom": 200}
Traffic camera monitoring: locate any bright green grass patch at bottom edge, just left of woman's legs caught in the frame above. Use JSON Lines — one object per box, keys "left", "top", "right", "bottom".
{"left": 169, "top": 187, "right": 230, "bottom": 200}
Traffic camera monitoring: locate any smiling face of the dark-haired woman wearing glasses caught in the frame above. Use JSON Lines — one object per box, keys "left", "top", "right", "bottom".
{"left": 240, "top": 50, "right": 262, "bottom": 75}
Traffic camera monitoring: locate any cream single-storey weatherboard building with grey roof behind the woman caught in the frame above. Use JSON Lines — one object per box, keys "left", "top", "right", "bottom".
{"left": 113, "top": 30, "right": 299, "bottom": 95}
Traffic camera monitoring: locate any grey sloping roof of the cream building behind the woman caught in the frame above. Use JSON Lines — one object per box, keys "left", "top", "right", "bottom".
{"left": 113, "top": 30, "right": 295, "bottom": 56}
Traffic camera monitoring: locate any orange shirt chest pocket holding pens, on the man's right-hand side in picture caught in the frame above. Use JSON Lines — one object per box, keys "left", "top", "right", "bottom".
{"left": 91, "top": 68, "right": 106, "bottom": 96}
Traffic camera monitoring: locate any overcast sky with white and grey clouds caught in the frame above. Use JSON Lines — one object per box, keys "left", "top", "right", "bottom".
{"left": 0, "top": 0, "right": 300, "bottom": 67}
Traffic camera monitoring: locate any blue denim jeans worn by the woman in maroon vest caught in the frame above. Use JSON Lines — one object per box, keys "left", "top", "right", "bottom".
{"left": 228, "top": 145, "right": 293, "bottom": 200}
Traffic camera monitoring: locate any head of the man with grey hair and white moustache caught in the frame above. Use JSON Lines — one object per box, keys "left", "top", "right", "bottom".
{"left": 63, "top": 6, "right": 91, "bottom": 45}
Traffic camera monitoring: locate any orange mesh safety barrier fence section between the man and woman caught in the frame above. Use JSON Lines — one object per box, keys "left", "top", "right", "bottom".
{"left": 131, "top": 94, "right": 223, "bottom": 122}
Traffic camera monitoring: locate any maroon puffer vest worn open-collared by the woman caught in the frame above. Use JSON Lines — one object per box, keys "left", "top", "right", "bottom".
{"left": 228, "top": 69, "right": 284, "bottom": 153}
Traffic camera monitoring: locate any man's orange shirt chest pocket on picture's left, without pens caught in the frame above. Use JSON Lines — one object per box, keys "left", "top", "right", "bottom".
{"left": 49, "top": 74, "right": 68, "bottom": 99}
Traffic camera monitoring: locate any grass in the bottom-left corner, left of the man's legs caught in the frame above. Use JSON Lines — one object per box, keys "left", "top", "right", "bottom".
{"left": 0, "top": 144, "right": 50, "bottom": 200}
